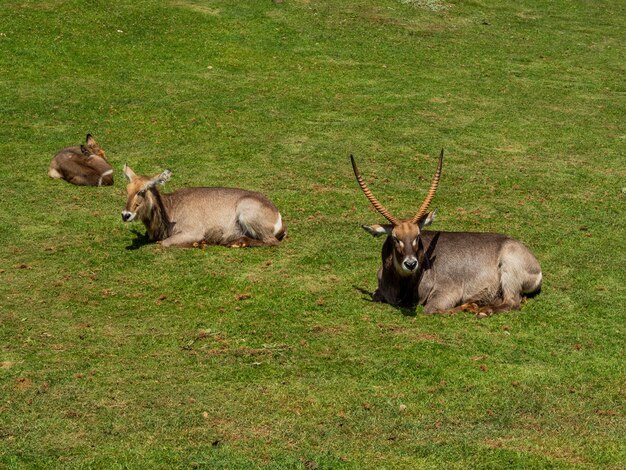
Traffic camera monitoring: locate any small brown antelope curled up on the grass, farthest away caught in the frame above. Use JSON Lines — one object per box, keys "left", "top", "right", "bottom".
{"left": 48, "top": 134, "right": 113, "bottom": 186}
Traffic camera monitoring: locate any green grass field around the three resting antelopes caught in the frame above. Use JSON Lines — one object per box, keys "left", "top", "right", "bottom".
{"left": 0, "top": 0, "right": 626, "bottom": 469}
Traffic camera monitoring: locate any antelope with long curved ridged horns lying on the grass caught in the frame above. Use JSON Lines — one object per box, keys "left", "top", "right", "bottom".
{"left": 350, "top": 149, "right": 541, "bottom": 317}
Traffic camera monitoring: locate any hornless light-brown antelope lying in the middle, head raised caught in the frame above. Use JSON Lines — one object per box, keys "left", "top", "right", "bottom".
{"left": 122, "top": 165, "right": 287, "bottom": 248}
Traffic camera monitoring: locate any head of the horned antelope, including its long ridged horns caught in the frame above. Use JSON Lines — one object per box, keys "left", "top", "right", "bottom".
{"left": 350, "top": 149, "right": 443, "bottom": 276}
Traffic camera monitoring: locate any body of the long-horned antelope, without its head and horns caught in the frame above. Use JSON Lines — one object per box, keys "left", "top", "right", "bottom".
{"left": 374, "top": 231, "right": 541, "bottom": 316}
